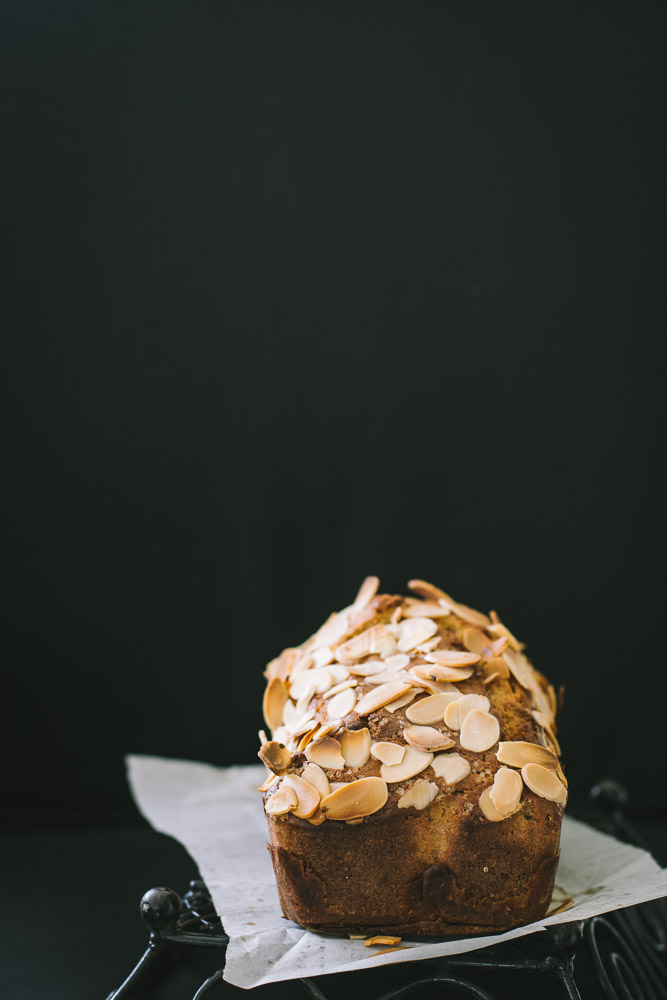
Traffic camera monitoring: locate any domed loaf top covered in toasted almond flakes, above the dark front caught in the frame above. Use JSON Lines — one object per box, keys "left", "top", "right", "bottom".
{"left": 259, "top": 576, "right": 567, "bottom": 825}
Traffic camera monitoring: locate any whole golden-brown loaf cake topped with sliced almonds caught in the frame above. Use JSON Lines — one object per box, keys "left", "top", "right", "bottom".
{"left": 260, "top": 577, "right": 567, "bottom": 937}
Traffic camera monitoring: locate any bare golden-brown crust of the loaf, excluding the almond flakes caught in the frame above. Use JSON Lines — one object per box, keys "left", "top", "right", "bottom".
{"left": 264, "top": 580, "right": 563, "bottom": 936}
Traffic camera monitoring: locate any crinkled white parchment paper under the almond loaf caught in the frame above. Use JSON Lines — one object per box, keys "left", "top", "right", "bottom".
{"left": 127, "top": 756, "right": 667, "bottom": 989}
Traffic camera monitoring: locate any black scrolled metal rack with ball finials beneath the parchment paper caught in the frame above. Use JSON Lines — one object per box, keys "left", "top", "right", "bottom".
{"left": 102, "top": 780, "right": 667, "bottom": 1000}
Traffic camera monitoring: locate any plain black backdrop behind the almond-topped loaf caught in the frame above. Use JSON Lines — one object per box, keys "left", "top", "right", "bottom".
{"left": 0, "top": 0, "right": 667, "bottom": 823}
